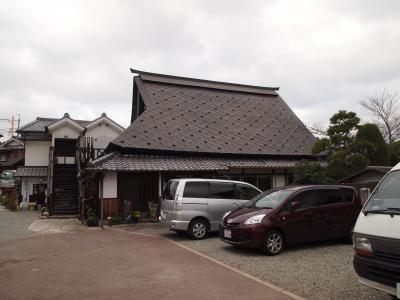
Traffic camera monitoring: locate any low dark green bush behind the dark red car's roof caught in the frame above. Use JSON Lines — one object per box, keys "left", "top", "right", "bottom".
{"left": 293, "top": 160, "right": 332, "bottom": 184}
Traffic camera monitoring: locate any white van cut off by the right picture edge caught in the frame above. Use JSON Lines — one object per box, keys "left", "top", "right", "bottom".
{"left": 353, "top": 163, "right": 400, "bottom": 298}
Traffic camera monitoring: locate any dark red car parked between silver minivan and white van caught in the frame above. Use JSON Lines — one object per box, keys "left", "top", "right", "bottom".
{"left": 220, "top": 185, "right": 361, "bottom": 255}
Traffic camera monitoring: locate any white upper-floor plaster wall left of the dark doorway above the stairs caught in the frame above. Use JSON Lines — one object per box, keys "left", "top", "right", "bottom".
{"left": 25, "top": 141, "right": 51, "bottom": 166}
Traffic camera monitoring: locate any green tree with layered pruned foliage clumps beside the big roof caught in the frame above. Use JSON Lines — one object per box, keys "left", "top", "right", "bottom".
{"left": 327, "top": 110, "right": 360, "bottom": 150}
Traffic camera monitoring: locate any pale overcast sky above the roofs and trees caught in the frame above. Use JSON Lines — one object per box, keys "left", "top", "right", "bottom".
{"left": 0, "top": 0, "right": 400, "bottom": 141}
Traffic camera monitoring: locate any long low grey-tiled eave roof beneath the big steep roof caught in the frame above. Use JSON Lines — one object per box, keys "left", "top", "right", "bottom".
{"left": 87, "top": 152, "right": 297, "bottom": 172}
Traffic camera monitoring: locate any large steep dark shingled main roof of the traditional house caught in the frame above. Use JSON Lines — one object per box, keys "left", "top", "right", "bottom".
{"left": 112, "top": 69, "right": 315, "bottom": 156}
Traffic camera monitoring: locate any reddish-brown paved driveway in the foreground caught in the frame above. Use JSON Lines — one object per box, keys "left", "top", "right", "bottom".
{"left": 0, "top": 230, "right": 290, "bottom": 300}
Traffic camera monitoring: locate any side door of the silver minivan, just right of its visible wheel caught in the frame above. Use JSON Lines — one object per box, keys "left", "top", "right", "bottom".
{"left": 208, "top": 181, "right": 238, "bottom": 230}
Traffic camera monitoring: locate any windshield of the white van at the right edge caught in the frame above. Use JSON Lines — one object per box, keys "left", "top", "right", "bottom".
{"left": 364, "top": 170, "right": 400, "bottom": 214}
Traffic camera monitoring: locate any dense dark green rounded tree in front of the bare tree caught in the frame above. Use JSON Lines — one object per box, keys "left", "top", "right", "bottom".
{"left": 354, "top": 123, "right": 389, "bottom": 166}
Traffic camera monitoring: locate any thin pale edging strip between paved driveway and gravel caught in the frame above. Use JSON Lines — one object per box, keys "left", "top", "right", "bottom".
{"left": 109, "top": 228, "right": 305, "bottom": 300}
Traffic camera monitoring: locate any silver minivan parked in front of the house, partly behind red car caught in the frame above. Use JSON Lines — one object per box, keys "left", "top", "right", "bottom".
{"left": 160, "top": 178, "right": 261, "bottom": 240}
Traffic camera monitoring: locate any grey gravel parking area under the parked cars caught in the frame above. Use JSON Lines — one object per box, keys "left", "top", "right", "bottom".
{"left": 113, "top": 225, "right": 391, "bottom": 299}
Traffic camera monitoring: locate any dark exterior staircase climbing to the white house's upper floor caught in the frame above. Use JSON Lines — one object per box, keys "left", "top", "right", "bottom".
{"left": 49, "top": 164, "right": 79, "bottom": 215}
